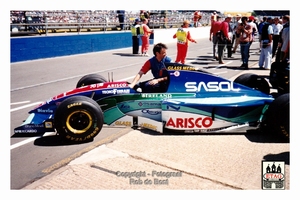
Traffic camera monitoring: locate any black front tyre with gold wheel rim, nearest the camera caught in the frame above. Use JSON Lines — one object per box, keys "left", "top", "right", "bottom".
{"left": 54, "top": 96, "right": 104, "bottom": 142}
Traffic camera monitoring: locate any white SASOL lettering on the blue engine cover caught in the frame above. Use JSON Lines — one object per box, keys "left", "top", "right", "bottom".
{"left": 184, "top": 81, "right": 240, "bottom": 92}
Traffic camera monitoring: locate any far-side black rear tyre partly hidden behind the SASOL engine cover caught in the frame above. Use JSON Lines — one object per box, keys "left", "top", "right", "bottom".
{"left": 234, "top": 73, "right": 270, "bottom": 94}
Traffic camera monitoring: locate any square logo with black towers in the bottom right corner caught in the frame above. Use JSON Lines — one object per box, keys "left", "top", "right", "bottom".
{"left": 262, "top": 161, "right": 285, "bottom": 190}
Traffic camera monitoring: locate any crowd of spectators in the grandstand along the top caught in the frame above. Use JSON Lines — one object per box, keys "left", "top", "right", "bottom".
{"left": 10, "top": 10, "right": 218, "bottom": 28}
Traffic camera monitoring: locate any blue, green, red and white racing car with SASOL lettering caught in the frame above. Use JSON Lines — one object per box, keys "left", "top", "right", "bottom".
{"left": 14, "top": 63, "right": 289, "bottom": 142}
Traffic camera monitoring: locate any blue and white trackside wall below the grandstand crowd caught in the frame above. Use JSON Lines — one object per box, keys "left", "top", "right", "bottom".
{"left": 10, "top": 27, "right": 210, "bottom": 63}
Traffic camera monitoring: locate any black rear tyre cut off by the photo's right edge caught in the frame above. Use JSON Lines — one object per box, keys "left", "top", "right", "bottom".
{"left": 260, "top": 93, "right": 290, "bottom": 140}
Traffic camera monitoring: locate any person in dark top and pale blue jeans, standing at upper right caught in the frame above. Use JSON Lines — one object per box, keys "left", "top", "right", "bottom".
{"left": 258, "top": 17, "right": 273, "bottom": 69}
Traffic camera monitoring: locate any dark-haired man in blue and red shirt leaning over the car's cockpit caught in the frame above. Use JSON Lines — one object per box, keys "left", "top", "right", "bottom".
{"left": 129, "top": 43, "right": 172, "bottom": 93}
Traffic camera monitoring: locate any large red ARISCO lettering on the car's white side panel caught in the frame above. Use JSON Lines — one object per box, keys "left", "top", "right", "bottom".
{"left": 166, "top": 117, "right": 213, "bottom": 128}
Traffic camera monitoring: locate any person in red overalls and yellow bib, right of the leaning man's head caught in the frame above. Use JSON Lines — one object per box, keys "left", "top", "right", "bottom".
{"left": 173, "top": 20, "right": 197, "bottom": 64}
